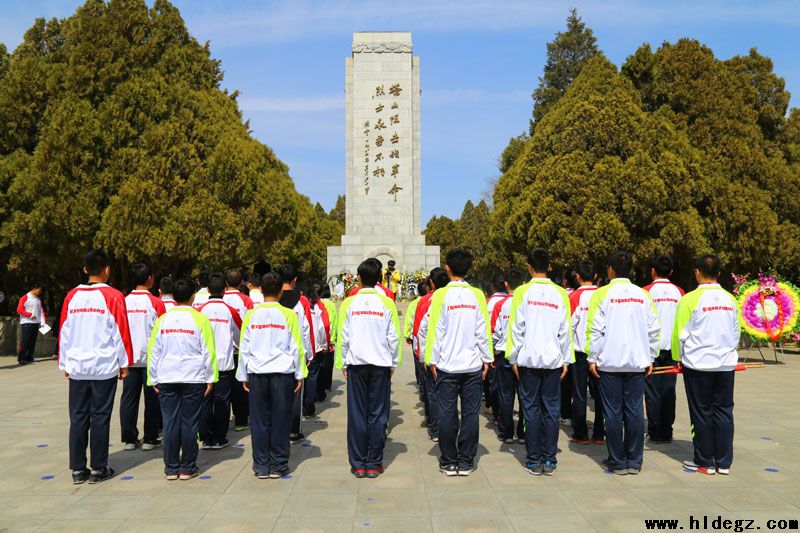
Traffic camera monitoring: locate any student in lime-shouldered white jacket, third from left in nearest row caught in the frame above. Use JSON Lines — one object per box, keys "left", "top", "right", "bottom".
{"left": 236, "top": 272, "right": 308, "bottom": 479}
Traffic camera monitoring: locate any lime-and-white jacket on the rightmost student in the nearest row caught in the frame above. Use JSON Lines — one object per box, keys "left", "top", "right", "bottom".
{"left": 672, "top": 283, "right": 741, "bottom": 371}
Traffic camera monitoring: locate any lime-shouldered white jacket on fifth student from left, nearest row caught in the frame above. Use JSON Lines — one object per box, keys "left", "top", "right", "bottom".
{"left": 425, "top": 281, "right": 494, "bottom": 373}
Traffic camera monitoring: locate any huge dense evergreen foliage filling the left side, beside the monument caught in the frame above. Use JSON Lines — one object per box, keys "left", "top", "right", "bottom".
{"left": 0, "top": 0, "right": 342, "bottom": 296}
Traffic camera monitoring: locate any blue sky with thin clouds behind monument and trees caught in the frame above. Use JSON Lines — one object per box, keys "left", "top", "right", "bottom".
{"left": 0, "top": 0, "right": 800, "bottom": 220}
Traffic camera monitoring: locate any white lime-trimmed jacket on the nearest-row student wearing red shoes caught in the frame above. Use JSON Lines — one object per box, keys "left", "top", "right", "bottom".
{"left": 336, "top": 287, "right": 402, "bottom": 368}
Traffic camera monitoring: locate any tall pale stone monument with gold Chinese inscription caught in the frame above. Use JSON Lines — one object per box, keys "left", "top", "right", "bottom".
{"left": 328, "top": 32, "right": 439, "bottom": 279}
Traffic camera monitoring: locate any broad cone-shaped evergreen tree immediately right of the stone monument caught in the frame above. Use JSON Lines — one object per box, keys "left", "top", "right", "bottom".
{"left": 492, "top": 55, "right": 709, "bottom": 282}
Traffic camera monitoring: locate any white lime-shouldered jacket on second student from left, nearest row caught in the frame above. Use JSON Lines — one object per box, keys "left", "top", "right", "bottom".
{"left": 147, "top": 305, "right": 219, "bottom": 385}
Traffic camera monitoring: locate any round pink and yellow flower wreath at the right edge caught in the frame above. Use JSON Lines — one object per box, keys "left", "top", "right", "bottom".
{"left": 736, "top": 274, "right": 800, "bottom": 342}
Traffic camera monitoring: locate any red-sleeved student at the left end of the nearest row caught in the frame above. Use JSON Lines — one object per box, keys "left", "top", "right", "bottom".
{"left": 58, "top": 250, "right": 133, "bottom": 485}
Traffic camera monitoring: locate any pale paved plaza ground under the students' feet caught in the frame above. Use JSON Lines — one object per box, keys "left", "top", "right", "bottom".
{"left": 0, "top": 334, "right": 800, "bottom": 532}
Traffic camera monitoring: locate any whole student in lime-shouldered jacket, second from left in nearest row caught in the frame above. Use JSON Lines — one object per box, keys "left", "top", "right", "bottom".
{"left": 147, "top": 278, "right": 218, "bottom": 481}
